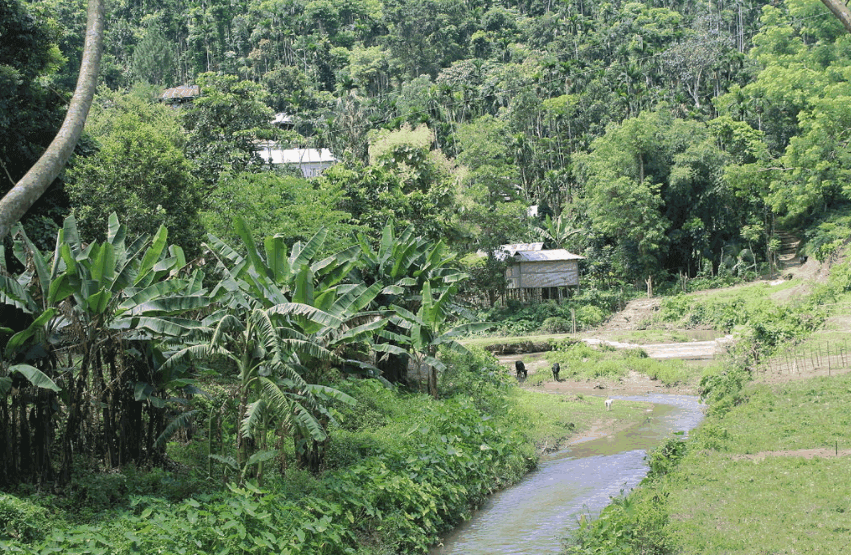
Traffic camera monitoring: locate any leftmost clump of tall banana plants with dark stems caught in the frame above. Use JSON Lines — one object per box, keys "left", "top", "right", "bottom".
{"left": 0, "top": 214, "right": 210, "bottom": 482}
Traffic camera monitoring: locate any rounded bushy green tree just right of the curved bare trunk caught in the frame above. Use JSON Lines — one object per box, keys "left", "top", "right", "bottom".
{"left": 66, "top": 92, "right": 203, "bottom": 256}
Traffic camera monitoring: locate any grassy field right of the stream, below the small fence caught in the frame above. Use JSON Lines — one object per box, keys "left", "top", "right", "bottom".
{"left": 664, "top": 375, "right": 851, "bottom": 554}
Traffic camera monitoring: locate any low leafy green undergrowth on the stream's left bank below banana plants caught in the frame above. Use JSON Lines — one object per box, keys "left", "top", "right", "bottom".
{"left": 0, "top": 351, "right": 644, "bottom": 555}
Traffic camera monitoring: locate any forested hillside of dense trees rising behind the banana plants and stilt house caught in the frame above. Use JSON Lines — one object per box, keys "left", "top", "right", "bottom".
{"left": 5, "top": 0, "right": 851, "bottom": 287}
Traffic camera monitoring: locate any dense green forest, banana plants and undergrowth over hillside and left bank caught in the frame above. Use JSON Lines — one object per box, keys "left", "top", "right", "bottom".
{"left": 0, "top": 0, "right": 851, "bottom": 554}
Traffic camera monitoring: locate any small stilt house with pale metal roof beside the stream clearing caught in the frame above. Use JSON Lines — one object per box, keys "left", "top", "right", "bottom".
{"left": 503, "top": 243, "right": 585, "bottom": 301}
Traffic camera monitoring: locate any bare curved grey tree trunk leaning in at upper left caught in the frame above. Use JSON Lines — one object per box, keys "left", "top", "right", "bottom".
{"left": 0, "top": 0, "right": 104, "bottom": 240}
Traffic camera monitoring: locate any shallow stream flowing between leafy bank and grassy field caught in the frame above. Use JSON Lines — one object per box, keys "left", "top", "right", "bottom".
{"left": 431, "top": 394, "right": 703, "bottom": 555}
